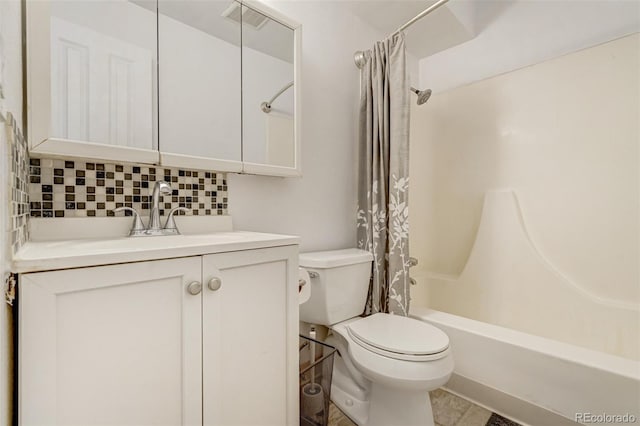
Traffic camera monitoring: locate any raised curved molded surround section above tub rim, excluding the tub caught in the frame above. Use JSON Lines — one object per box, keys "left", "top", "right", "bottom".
{"left": 428, "top": 190, "right": 640, "bottom": 360}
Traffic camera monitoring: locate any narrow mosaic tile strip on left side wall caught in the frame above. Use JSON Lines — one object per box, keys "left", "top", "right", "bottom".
{"left": 5, "top": 113, "right": 29, "bottom": 254}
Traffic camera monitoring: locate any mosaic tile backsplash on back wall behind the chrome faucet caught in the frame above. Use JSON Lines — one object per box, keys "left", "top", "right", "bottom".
{"left": 29, "top": 158, "right": 228, "bottom": 217}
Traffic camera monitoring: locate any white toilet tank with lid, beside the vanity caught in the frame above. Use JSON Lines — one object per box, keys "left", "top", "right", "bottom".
{"left": 300, "top": 249, "right": 373, "bottom": 326}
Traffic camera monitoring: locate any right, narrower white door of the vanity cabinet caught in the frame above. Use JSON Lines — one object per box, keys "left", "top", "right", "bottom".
{"left": 202, "top": 246, "right": 299, "bottom": 426}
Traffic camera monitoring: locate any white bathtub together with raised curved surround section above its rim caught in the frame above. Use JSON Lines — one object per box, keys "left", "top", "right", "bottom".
{"left": 404, "top": 190, "right": 640, "bottom": 425}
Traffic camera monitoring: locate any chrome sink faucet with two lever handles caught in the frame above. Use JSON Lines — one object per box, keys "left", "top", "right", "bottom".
{"left": 113, "top": 180, "right": 189, "bottom": 237}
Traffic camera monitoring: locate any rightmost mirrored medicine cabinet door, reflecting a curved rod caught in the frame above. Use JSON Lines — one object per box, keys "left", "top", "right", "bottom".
{"left": 242, "top": 3, "right": 300, "bottom": 176}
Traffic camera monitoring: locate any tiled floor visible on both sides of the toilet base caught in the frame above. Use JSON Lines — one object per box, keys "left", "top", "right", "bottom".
{"left": 329, "top": 389, "right": 519, "bottom": 426}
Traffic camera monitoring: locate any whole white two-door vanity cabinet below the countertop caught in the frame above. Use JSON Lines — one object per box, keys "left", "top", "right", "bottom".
{"left": 19, "top": 245, "right": 298, "bottom": 426}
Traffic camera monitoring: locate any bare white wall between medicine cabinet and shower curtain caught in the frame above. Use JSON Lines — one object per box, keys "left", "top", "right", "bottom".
{"left": 228, "top": 1, "right": 384, "bottom": 251}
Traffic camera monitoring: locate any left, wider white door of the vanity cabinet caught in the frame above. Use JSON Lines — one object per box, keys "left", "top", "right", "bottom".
{"left": 19, "top": 257, "right": 202, "bottom": 426}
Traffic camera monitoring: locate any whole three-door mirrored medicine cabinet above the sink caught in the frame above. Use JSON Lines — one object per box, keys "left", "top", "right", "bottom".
{"left": 26, "top": 0, "right": 301, "bottom": 176}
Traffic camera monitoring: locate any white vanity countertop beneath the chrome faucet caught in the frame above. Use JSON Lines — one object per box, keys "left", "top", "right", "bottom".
{"left": 12, "top": 231, "right": 300, "bottom": 273}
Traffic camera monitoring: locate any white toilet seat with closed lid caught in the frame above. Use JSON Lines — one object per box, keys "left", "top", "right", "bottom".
{"left": 345, "top": 313, "right": 449, "bottom": 362}
